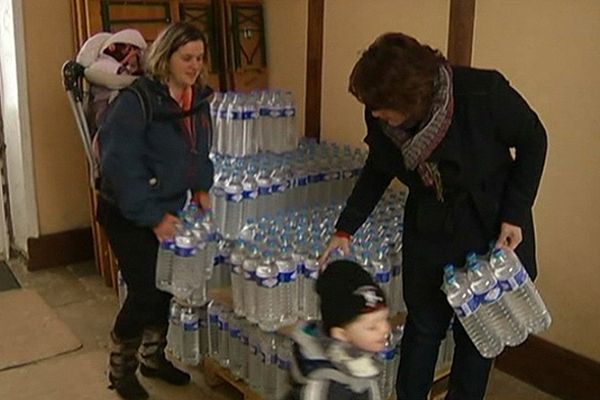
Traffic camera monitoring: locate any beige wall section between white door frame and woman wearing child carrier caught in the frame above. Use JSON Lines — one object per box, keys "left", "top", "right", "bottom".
{"left": 23, "top": 0, "right": 90, "bottom": 235}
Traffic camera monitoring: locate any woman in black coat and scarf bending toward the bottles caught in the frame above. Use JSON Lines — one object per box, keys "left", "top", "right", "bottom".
{"left": 322, "top": 33, "right": 546, "bottom": 400}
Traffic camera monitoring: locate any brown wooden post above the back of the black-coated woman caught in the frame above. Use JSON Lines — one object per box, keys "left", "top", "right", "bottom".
{"left": 448, "top": 0, "right": 475, "bottom": 66}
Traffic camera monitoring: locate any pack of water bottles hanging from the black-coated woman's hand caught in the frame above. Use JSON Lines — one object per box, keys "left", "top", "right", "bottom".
{"left": 443, "top": 248, "right": 552, "bottom": 358}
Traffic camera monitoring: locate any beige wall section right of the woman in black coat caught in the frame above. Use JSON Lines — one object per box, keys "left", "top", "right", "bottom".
{"left": 473, "top": 0, "right": 600, "bottom": 361}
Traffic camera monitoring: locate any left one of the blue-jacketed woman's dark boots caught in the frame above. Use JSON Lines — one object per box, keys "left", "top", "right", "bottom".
{"left": 108, "top": 332, "right": 148, "bottom": 400}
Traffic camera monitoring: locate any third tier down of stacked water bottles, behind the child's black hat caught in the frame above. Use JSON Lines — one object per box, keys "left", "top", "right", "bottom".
{"left": 225, "top": 190, "right": 405, "bottom": 332}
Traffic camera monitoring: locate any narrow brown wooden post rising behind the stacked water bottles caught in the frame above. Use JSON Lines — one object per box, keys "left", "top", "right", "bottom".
{"left": 304, "top": 0, "right": 325, "bottom": 140}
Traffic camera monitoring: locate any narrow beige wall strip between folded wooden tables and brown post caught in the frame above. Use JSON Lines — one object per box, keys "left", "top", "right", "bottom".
{"left": 263, "top": 0, "right": 308, "bottom": 135}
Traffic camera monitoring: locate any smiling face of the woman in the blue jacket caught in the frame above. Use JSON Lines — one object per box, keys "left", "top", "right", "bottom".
{"left": 168, "top": 40, "right": 204, "bottom": 89}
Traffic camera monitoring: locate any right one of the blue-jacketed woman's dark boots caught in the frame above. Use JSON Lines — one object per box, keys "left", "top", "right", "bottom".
{"left": 140, "top": 328, "right": 190, "bottom": 386}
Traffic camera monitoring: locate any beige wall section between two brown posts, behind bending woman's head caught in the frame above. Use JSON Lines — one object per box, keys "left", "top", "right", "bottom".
{"left": 321, "top": 0, "right": 449, "bottom": 146}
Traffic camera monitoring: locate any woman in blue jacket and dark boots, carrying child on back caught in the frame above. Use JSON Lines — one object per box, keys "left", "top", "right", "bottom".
{"left": 98, "top": 23, "right": 213, "bottom": 399}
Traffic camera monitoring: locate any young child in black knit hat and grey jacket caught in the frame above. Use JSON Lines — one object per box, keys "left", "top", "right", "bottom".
{"left": 288, "top": 260, "right": 390, "bottom": 400}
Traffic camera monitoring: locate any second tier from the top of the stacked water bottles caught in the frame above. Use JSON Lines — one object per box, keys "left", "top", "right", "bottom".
{"left": 211, "top": 141, "right": 366, "bottom": 239}
